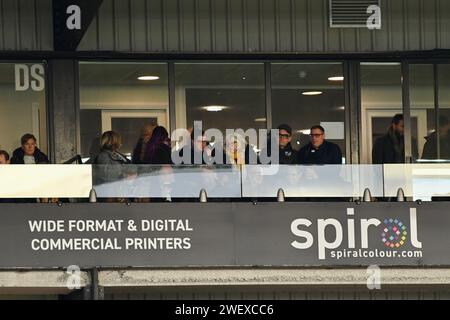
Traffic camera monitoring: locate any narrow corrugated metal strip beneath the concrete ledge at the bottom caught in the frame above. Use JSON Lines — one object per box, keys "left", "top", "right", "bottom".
{"left": 105, "top": 290, "right": 450, "bottom": 300}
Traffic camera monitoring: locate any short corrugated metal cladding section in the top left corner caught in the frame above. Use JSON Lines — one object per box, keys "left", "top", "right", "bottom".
{"left": 0, "top": 0, "right": 53, "bottom": 51}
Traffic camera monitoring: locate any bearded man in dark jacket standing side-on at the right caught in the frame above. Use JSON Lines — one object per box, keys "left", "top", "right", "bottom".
{"left": 372, "top": 114, "right": 405, "bottom": 164}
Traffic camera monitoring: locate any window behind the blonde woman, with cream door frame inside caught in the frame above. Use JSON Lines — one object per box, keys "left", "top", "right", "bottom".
{"left": 79, "top": 62, "right": 169, "bottom": 158}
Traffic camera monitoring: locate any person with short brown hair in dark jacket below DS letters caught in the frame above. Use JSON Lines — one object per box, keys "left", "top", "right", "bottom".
{"left": 11, "top": 133, "right": 50, "bottom": 164}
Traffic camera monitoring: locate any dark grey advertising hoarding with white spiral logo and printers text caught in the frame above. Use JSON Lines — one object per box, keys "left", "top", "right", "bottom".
{"left": 0, "top": 202, "right": 450, "bottom": 268}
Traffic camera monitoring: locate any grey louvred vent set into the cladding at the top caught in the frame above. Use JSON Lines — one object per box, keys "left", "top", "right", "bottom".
{"left": 329, "top": 0, "right": 380, "bottom": 28}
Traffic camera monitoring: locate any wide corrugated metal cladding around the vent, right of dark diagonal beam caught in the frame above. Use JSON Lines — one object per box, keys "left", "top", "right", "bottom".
{"left": 78, "top": 0, "right": 450, "bottom": 52}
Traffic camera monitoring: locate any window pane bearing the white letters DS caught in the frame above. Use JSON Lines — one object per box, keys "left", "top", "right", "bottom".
{"left": 0, "top": 62, "right": 48, "bottom": 155}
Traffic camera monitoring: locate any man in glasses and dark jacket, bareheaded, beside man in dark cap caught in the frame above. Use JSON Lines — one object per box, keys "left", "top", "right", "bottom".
{"left": 298, "top": 125, "right": 342, "bottom": 164}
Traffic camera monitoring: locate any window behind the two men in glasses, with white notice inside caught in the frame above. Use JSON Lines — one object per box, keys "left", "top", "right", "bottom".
{"left": 272, "top": 63, "right": 345, "bottom": 161}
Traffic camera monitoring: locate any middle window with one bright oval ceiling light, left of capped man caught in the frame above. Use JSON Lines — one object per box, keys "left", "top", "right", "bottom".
{"left": 175, "top": 63, "right": 266, "bottom": 139}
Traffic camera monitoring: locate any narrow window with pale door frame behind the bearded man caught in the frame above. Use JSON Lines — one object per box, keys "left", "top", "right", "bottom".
{"left": 360, "top": 62, "right": 402, "bottom": 163}
